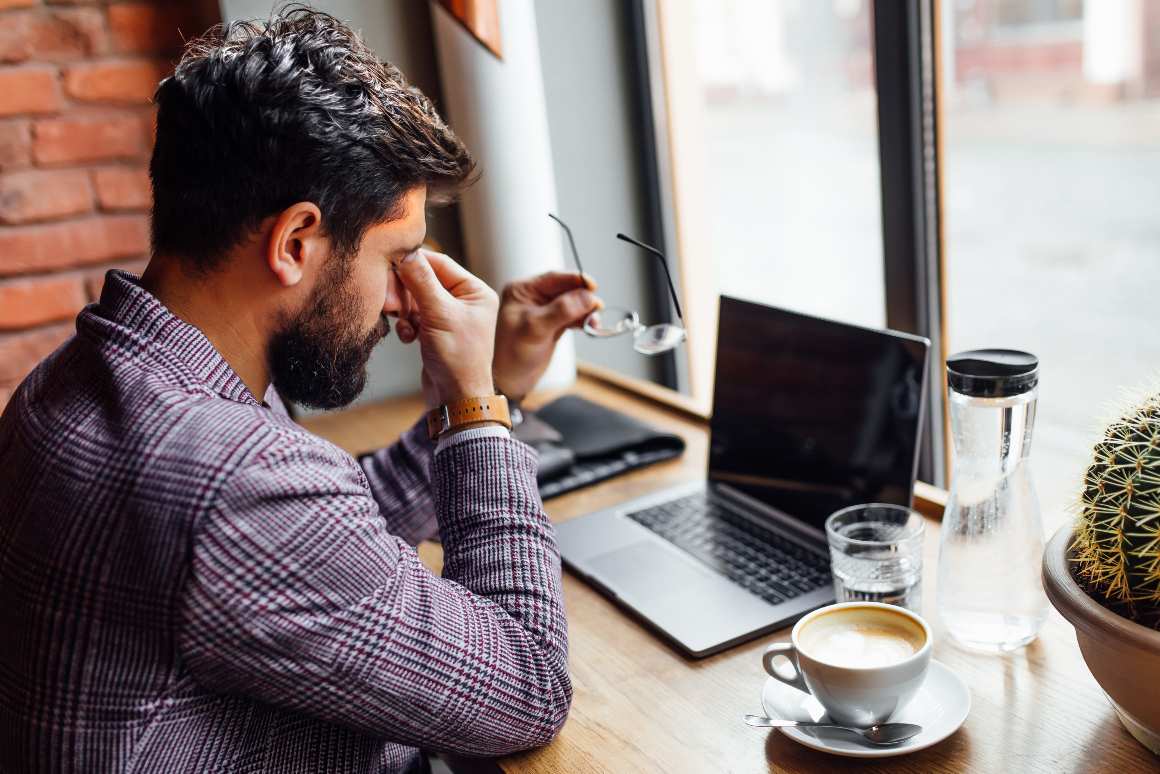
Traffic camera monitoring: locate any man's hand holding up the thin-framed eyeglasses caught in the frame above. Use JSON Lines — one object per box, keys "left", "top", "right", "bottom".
{"left": 494, "top": 272, "right": 603, "bottom": 400}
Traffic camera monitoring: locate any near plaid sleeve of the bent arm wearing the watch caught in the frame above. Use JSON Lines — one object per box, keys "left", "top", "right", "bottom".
{"left": 180, "top": 436, "right": 572, "bottom": 755}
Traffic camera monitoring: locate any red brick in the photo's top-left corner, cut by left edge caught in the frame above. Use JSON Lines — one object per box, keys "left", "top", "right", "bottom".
{"left": 0, "top": 8, "right": 107, "bottom": 62}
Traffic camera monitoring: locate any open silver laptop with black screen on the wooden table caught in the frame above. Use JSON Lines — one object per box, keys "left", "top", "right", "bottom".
{"left": 557, "top": 296, "right": 930, "bottom": 658}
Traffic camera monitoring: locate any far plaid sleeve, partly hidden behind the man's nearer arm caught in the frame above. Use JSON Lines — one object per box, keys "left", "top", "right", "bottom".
{"left": 358, "top": 419, "right": 438, "bottom": 545}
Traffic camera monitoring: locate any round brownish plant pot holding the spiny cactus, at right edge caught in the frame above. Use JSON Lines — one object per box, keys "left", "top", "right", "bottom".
{"left": 1043, "top": 527, "right": 1160, "bottom": 755}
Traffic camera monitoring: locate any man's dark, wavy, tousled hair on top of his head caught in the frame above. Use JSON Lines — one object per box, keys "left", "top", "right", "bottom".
{"left": 150, "top": 5, "right": 474, "bottom": 270}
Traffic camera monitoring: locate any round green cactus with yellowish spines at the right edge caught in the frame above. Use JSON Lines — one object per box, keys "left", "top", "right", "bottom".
{"left": 1072, "top": 396, "right": 1160, "bottom": 629}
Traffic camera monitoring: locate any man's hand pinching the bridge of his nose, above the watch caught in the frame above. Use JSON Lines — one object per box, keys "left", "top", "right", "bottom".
{"left": 397, "top": 249, "right": 499, "bottom": 408}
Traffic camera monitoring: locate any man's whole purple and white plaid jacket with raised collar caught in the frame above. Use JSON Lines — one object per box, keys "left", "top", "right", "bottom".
{"left": 0, "top": 272, "right": 572, "bottom": 772}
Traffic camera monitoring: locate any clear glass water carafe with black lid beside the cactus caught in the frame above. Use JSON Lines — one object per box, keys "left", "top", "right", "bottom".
{"left": 937, "top": 349, "right": 1047, "bottom": 652}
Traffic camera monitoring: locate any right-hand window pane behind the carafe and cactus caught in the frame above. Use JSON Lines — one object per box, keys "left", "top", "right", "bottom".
{"left": 940, "top": 0, "right": 1160, "bottom": 527}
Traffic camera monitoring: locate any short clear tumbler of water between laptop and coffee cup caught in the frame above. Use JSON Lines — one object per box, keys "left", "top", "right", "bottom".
{"left": 826, "top": 502, "right": 923, "bottom": 613}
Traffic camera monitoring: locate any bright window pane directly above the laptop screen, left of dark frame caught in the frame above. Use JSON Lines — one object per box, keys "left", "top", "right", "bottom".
{"left": 674, "top": 0, "right": 885, "bottom": 326}
